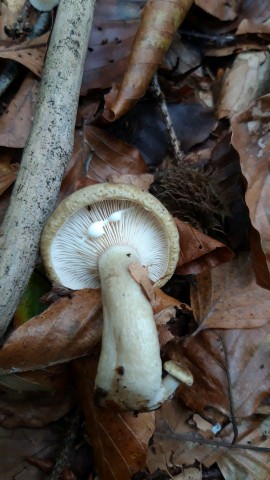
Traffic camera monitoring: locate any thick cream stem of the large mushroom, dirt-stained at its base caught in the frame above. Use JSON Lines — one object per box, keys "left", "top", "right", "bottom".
{"left": 96, "top": 245, "right": 167, "bottom": 411}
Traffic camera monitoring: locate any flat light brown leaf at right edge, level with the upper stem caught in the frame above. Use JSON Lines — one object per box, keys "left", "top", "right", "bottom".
{"left": 191, "top": 254, "right": 270, "bottom": 331}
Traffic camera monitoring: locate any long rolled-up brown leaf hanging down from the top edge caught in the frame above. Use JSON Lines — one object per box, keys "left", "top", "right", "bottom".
{"left": 104, "top": 0, "right": 193, "bottom": 121}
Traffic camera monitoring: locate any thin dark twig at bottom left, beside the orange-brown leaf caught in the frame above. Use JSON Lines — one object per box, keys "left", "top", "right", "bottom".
{"left": 46, "top": 409, "right": 82, "bottom": 480}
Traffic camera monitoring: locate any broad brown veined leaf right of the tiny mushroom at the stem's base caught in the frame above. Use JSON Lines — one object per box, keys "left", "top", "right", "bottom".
{"left": 164, "top": 323, "right": 270, "bottom": 417}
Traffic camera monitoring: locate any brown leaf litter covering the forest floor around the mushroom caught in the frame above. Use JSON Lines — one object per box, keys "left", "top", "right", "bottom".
{"left": 0, "top": 0, "right": 270, "bottom": 480}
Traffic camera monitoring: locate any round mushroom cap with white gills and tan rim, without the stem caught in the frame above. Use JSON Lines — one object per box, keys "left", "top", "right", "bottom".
{"left": 41, "top": 183, "right": 179, "bottom": 290}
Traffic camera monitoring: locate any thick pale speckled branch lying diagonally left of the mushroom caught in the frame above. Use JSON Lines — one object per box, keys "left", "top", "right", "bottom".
{"left": 0, "top": 0, "right": 95, "bottom": 338}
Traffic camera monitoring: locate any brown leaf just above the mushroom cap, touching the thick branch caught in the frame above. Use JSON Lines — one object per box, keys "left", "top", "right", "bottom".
{"left": 59, "top": 125, "right": 147, "bottom": 201}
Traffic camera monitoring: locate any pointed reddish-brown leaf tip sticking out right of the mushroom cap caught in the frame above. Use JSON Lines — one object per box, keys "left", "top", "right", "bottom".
{"left": 174, "top": 218, "right": 234, "bottom": 275}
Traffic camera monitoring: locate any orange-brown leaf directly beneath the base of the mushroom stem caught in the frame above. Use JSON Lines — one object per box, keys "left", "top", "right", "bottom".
{"left": 73, "top": 357, "right": 154, "bottom": 480}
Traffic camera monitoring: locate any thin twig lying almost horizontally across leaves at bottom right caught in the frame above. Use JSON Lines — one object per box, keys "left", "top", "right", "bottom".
{"left": 155, "top": 432, "right": 270, "bottom": 453}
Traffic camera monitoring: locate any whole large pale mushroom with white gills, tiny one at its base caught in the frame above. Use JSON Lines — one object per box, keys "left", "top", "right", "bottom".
{"left": 41, "top": 183, "right": 192, "bottom": 411}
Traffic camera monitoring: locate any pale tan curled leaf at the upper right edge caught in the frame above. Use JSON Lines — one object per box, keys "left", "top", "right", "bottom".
{"left": 218, "top": 52, "right": 270, "bottom": 118}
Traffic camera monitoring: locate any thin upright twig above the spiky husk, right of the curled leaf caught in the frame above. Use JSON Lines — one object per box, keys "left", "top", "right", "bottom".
{"left": 152, "top": 75, "right": 185, "bottom": 162}
